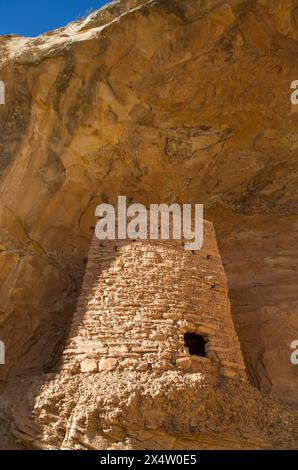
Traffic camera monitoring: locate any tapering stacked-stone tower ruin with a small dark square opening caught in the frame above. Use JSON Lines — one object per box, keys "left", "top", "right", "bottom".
{"left": 63, "top": 217, "right": 245, "bottom": 383}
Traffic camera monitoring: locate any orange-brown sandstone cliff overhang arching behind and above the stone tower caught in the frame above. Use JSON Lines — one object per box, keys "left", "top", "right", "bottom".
{"left": 0, "top": 0, "right": 298, "bottom": 430}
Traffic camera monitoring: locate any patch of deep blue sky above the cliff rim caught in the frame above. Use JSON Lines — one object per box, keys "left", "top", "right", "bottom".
{"left": 0, "top": 0, "right": 109, "bottom": 36}
